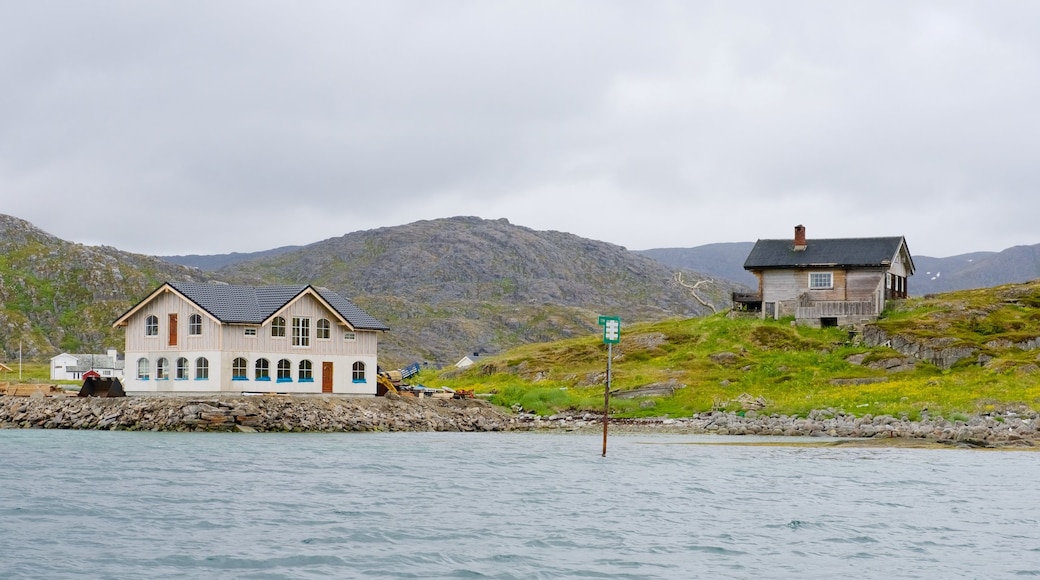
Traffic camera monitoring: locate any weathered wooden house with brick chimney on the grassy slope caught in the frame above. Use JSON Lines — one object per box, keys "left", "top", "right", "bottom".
{"left": 733, "top": 226, "right": 914, "bottom": 326}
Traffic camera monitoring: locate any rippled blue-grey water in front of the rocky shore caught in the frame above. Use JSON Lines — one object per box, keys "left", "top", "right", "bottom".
{"left": 0, "top": 430, "right": 1040, "bottom": 578}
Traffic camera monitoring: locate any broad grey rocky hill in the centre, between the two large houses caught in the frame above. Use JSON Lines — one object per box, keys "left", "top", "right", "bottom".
{"left": 215, "top": 217, "right": 737, "bottom": 363}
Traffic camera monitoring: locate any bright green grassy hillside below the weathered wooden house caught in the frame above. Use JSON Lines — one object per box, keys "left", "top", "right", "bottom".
{"left": 421, "top": 283, "right": 1040, "bottom": 419}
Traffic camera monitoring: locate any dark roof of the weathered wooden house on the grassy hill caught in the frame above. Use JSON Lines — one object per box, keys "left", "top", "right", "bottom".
{"left": 744, "top": 236, "right": 913, "bottom": 271}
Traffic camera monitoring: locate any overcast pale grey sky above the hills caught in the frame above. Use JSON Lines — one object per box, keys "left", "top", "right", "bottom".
{"left": 0, "top": 0, "right": 1040, "bottom": 257}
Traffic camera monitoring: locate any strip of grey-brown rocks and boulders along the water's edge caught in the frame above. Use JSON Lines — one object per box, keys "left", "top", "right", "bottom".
{"left": 0, "top": 396, "right": 1040, "bottom": 449}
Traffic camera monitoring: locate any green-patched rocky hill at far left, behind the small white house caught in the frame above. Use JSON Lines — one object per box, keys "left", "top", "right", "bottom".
{"left": 0, "top": 214, "right": 213, "bottom": 361}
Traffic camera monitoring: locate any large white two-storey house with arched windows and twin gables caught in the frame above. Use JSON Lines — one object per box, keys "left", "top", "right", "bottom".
{"left": 112, "top": 282, "right": 389, "bottom": 395}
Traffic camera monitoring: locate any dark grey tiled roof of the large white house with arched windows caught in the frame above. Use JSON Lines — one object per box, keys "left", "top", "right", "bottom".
{"left": 167, "top": 282, "right": 390, "bottom": 331}
